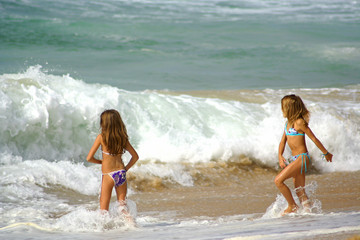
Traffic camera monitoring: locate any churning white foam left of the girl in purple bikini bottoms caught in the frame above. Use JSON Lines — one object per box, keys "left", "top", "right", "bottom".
{"left": 0, "top": 157, "right": 137, "bottom": 232}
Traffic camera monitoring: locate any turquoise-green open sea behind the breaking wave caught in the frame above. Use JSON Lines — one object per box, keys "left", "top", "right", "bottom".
{"left": 0, "top": 0, "right": 360, "bottom": 90}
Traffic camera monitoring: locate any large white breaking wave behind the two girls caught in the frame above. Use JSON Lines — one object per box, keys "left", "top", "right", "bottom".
{"left": 0, "top": 66, "right": 360, "bottom": 174}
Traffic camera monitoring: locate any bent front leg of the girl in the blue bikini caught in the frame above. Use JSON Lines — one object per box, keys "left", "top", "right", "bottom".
{"left": 275, "top": 156, "right": 301, "bottom": 214}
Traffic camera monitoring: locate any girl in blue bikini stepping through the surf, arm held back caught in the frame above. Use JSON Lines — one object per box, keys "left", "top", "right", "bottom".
{"left": 275, "top": 95, "right": 333, "bottom": 214}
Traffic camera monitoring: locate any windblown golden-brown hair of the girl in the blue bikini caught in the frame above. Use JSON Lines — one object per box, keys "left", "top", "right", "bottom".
{"left": 281, "top": 94, "right": 310, "bottom": 126}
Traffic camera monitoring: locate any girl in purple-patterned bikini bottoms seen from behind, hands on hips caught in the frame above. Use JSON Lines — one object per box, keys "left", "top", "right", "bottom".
{"left": 86, "top": 110, "right": 139, "bottom": 215}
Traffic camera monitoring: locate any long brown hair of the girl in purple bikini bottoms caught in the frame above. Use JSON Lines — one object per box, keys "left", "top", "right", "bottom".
{"left": 100, "top": 109, "right": 129, "bottom": 155}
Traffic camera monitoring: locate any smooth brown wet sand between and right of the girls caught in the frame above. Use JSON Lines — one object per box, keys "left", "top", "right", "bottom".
{"left": 131, "top": 170, "right": 360, "bottom": 219}
